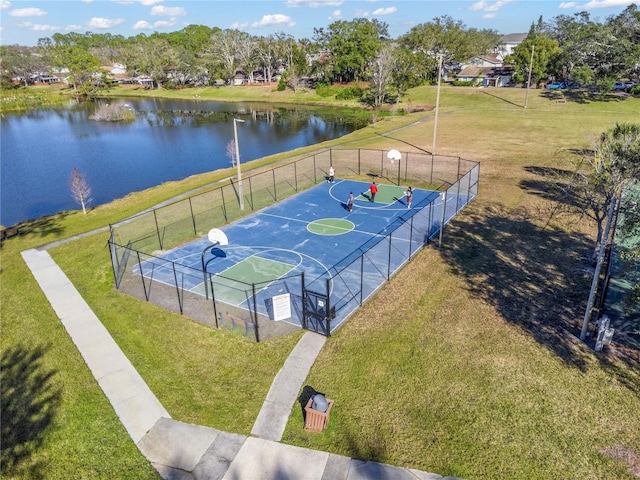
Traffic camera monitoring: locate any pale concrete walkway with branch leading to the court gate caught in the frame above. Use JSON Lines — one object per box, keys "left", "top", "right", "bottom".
{"left": 22, "top": 250, "right": 460, "bottom": 480}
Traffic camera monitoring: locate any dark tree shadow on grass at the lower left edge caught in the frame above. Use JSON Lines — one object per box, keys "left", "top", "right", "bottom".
{"left": 0, "top": 346, "right": 61, "bottom": 478}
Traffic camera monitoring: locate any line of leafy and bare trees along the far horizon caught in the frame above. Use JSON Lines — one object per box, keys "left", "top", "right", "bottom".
{"left": 0, "top": 4, "right": 640, "bottom": 102}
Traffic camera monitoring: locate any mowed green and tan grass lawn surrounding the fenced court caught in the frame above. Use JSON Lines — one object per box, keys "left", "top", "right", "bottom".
{"left": 0, "top": 87, "right": 640, "bottom": 479}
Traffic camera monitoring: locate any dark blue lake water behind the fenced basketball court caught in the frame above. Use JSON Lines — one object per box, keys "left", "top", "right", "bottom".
{"left": 0, "top": 98, "right": 367, "bottom": 226}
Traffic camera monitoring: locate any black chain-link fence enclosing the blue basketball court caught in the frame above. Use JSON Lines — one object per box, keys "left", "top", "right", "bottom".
{"left": 109, "top": 149, "right": 479, "bottom": 342}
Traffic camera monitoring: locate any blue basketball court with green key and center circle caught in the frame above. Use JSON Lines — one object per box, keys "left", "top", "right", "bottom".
{"left": 136, "top": 179, "right": 456, "bottom": 331}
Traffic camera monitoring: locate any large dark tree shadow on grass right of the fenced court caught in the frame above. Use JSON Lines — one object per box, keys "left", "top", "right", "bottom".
{"left": 442, "top": 199, "right": 640, "bottom": 392}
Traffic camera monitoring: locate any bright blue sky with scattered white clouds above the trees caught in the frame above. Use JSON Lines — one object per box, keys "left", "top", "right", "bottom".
{"left": 0, "top": 0, "right": 638, "bottom": 46}
